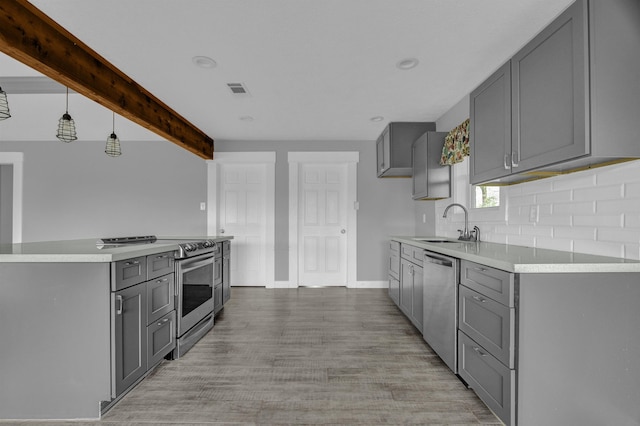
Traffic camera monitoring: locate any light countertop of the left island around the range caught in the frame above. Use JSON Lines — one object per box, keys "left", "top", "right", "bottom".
{"left": 0, "top": 235, "right": 233, "bottom": 263}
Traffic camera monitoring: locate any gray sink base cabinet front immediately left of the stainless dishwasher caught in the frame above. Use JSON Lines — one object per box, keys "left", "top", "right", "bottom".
{"left": 399, "top": 244, "right": 424, "bottom": 333}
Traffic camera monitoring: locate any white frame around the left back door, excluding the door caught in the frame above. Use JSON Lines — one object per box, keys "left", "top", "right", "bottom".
{"left": 207, "top": 151, "right": 276, "bottom": 288}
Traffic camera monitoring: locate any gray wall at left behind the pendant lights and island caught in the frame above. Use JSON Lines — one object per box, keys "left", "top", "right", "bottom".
{"left": 0, "top": 137, "right": 207, "bottom": 242}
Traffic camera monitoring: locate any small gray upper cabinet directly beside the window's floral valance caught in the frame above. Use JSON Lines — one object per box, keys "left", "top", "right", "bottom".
{"left": 411, "top": 132, "right": 451, "bottom": 200}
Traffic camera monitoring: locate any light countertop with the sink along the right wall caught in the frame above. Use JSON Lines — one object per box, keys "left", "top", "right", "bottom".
{"left": 391, "top": 236, "right": 640, "bottom": 273}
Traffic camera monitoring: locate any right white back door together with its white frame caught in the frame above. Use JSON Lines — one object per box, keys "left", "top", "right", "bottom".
{"left": 289, "top": 152, "right": 358, "bottom": 287}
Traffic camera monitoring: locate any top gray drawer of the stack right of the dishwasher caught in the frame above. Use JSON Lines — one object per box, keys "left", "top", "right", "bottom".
{"left": 460, "top": 260, "right": 516, "bottom": 308}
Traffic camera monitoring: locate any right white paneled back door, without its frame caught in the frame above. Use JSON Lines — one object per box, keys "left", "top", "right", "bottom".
{"left": 298, "top": 163, "right": 347, "bottom": 286}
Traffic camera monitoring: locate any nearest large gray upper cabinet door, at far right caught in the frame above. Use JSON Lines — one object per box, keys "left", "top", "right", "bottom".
{"left": 511, "top": 1, "right": 589, "bottom": 172}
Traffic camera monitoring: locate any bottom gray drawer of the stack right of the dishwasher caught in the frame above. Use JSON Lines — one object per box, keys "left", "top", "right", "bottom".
{"left": 458, "top": 331, "right": 516, "bottom": 425}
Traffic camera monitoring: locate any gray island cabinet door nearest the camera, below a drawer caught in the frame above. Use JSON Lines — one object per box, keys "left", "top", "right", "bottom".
{"left": 114, "top": 283, "right": 147, "bottom": 396}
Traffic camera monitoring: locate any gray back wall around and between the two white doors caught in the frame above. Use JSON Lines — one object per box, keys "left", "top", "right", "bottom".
{"left": 215, "top": 141, "right": 414, "bottom": 281}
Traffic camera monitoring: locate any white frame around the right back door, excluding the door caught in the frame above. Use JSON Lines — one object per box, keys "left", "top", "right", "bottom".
{"left": 288, "top": 151, "right": 360, "bottom": 288}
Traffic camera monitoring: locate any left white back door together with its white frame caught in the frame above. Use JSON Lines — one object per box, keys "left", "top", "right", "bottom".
{"left": 209, "top": 153, "right": 275, "bottom": 287}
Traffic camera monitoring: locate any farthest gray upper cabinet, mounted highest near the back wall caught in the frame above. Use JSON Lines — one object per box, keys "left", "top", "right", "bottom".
{"left": 376, "top": 122, "right": 436, "bottom": 177}
